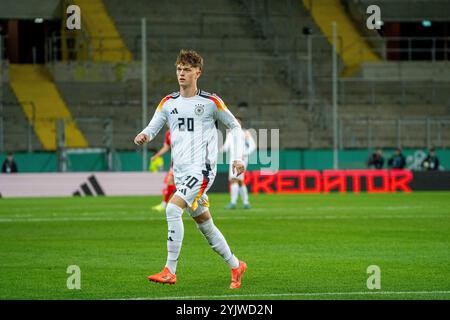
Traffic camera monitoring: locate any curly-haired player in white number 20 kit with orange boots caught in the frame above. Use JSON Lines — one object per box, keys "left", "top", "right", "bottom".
{"left": 134, "top": 50, "right": 247, "bottom": 289}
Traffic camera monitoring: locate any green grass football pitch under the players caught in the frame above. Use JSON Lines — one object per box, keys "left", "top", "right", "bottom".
{"left": 0, "top": 192, "right": 450, "bottom": 300}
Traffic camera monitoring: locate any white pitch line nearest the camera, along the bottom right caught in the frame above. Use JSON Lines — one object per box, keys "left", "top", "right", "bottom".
{"left": 116, "top": 291, "right": 450, "bottom": 300}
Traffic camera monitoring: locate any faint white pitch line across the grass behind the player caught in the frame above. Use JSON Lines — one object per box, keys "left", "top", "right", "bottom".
{"left": 0, "top": 215, "right": 450, "bottom": 223}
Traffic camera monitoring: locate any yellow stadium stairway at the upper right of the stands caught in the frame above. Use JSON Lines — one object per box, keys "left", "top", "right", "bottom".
{"left": 303, "top": 0, "right": 380, "bottom": 77}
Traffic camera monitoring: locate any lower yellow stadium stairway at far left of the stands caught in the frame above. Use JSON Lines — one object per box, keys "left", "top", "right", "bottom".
{"left": 10, "top": 64, "right": 88, "bottom": 150}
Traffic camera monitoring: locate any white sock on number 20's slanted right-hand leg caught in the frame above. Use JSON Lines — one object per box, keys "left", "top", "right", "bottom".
{"left": 197, "top": 218, "right": 239, "bottom": 269}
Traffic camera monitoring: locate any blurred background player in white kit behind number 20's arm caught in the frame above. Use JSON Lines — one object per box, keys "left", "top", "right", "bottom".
{"left": 221, "top": 117, "right": 256, "bottom": 209}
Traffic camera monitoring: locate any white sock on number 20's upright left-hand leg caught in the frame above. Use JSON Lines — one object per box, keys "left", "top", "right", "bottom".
{"left": 166, "top": 203, "right": 184, "bottom": 274}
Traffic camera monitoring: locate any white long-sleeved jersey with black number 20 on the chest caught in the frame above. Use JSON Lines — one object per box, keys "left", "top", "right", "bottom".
{"left": 141, "top": 90, "right": 244, "bottom": 177}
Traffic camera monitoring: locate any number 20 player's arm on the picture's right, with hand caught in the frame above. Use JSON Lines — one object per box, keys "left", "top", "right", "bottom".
{"left": 214, "top": 96, "right": 245, "bottom": 176}
